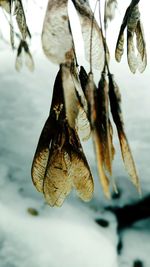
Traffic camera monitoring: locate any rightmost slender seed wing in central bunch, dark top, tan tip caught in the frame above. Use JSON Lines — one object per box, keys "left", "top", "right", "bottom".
{"left": 109, "top": 74, "right": 140, "bottom": 191}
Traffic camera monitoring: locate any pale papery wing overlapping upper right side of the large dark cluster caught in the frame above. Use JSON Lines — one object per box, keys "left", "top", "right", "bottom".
{"left": 62, "top": 65, "right": 91, "bottom": 140}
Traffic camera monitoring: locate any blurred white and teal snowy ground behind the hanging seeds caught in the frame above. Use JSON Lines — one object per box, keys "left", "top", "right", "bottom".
{"left": 0, "top": 1, "right": 150, "bottom": 267}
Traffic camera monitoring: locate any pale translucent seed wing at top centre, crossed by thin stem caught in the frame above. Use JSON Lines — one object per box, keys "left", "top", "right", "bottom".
{"left": 72, "top": 0, "right": 104, "bottom": 70}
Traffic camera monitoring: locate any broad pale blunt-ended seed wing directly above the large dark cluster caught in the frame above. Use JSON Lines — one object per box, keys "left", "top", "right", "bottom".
{"left": 42, "top": 0, "right": 73, "bottom": 64}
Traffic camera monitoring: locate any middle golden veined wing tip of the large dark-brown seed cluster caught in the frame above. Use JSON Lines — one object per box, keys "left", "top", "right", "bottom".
{"left": 44, "top": 149, "right": 72, "bottom": 207}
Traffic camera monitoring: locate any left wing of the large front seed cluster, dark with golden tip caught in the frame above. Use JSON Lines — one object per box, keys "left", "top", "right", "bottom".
{"left": 32, "top": 68, "right": 65, "bottom": 192}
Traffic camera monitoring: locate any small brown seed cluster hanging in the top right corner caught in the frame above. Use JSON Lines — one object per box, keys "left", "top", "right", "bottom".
{"left": 115, "top": 0, "right": 147, "bottom": 73}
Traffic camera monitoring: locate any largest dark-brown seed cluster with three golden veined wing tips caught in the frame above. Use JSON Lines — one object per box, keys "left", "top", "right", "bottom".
{"left": 32, "top": 66, "right": 94, "bottom": 206}
